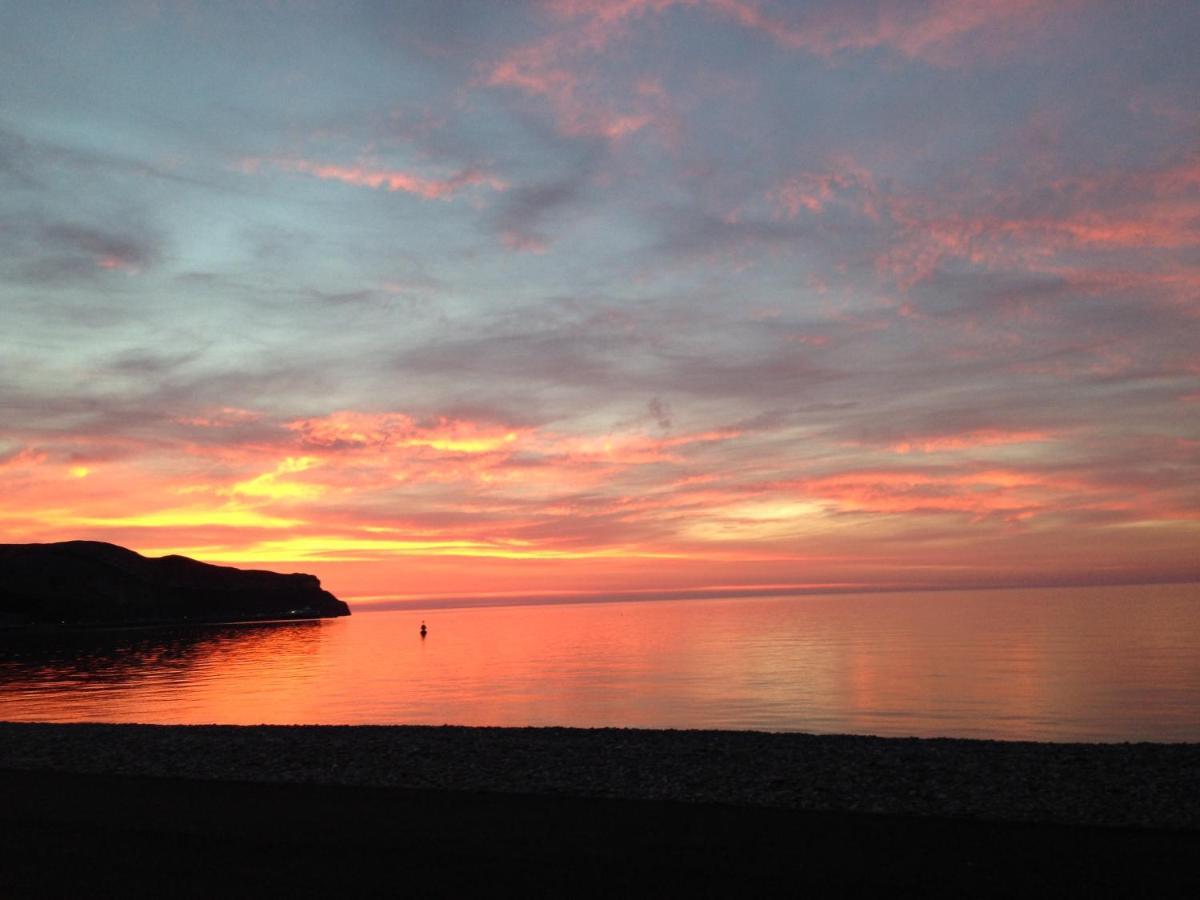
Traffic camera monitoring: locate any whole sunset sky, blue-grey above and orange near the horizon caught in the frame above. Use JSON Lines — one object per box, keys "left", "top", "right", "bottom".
{"left": 0, "top": 0, "right": 1200, "bottom": 602}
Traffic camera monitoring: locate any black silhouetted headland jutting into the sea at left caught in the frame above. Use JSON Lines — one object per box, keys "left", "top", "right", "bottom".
{"left": 0, "top": 541, "right": 350, "bottom": 626}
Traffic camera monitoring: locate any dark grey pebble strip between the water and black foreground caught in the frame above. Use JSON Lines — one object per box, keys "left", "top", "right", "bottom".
{"left": 0, "top": 722, "right": 1200, "bottom": 830}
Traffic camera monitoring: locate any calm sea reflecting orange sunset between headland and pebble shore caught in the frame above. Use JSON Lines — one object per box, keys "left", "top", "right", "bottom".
{"left": 0, "top": 584, "right": 1200, "bottom": 740}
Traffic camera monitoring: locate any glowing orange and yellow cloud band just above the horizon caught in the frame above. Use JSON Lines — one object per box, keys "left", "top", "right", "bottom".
{"left": 7, "top": 398, "right": 1196, "bottom": 596}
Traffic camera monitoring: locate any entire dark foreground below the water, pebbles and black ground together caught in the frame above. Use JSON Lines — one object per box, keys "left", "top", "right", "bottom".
{"left": 0, "top": 725, "right": 1200, "bottom": 898}
